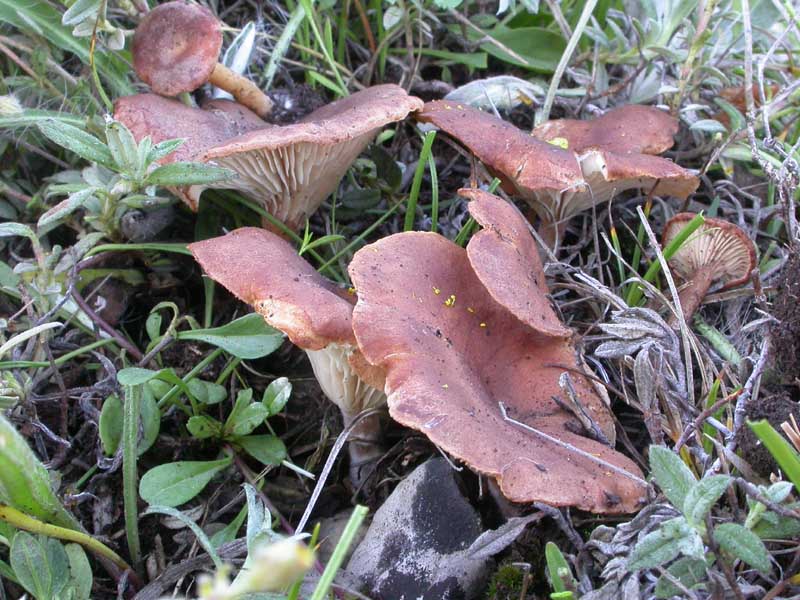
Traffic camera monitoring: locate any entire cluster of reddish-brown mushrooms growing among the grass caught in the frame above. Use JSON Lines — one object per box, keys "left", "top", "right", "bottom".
{"left": 115, "top": 1, "right": 755, "bottom": 513}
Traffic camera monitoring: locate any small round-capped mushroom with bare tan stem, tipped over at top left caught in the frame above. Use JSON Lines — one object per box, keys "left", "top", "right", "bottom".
{"left": 133, "top": 0, "right": 272, "bottom": 117}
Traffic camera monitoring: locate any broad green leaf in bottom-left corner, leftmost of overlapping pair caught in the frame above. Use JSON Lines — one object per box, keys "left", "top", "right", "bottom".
{"left": 10, "top": 531, "right": 69, "bottom": 600}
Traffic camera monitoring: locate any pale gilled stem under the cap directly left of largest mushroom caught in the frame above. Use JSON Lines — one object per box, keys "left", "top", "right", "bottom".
{"left": 306, "top": 344, "right": 386, "bottom": 487}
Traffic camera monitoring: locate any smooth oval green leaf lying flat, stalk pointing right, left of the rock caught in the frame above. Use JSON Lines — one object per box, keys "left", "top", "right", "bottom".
{"left": 139, "top": 457, "right": 232, "bottom": 507}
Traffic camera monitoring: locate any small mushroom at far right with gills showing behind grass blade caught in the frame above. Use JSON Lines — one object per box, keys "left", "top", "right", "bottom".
{"left": 662, "top": 213, "right": 756, "bottom": 321}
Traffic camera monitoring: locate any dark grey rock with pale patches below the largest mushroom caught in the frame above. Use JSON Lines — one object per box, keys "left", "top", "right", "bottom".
{"left": 347, "top": 458, "right": 500, "bottom": 600}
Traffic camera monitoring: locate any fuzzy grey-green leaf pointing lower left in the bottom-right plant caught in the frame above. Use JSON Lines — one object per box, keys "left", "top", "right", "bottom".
{"left": 627, "top": 517, "right": 703, "bottom": 571}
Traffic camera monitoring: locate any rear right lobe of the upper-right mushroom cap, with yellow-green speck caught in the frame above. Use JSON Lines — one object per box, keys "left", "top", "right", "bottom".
{"left": 533, "top": 104, "right": 678, "bottom": 154}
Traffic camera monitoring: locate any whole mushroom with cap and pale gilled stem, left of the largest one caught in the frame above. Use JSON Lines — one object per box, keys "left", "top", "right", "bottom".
{"left": 189, "top": 227, "right": 386, "bottom": 486}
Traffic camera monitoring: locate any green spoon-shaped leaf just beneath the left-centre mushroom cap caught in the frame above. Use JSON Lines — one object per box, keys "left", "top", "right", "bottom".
{"left": 177, "top": 313, "right": 283, "bottom": 359}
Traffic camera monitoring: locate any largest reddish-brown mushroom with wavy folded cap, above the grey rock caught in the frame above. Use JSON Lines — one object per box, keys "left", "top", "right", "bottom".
{"left": 349, "top": 191, "right": 646, "bottom": 513}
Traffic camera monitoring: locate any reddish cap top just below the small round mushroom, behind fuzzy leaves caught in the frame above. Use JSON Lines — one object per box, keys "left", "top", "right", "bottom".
{"left": 114, "top": 94, "right": 266, "bottom": 164}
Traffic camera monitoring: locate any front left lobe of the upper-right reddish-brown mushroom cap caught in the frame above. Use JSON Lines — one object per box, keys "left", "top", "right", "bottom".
{"left": 416, "top": 100, "right": 583, "bottom": 196}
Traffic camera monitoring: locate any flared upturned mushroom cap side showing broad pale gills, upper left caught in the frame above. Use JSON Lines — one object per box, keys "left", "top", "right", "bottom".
{"left": 190, "top": 84, "right": 422, "bottom": 228}
